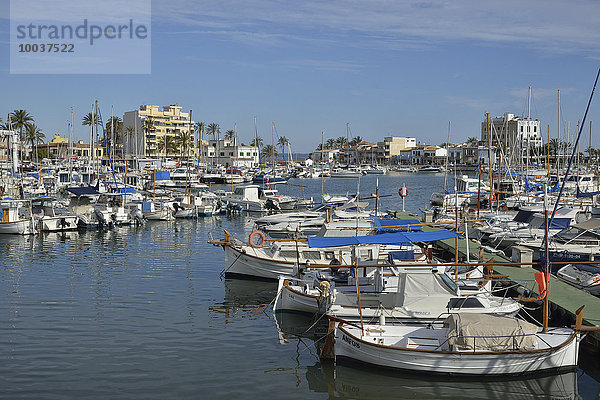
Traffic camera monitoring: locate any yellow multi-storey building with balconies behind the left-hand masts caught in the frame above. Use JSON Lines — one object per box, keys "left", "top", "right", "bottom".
{"left": 123, "top": 104, "right": 195, "bottom": 157}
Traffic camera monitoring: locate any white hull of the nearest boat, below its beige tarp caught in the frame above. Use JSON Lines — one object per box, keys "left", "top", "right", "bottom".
{"left": 334, "top": 326, "right": 579, "bottom": 375}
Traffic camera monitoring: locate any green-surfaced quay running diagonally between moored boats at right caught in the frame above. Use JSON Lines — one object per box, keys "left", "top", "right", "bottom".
{"left": 388, "top": 210, "right": 600, "bottom": 352}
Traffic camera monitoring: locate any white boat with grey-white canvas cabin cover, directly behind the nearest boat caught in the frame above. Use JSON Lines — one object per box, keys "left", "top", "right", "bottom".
{"left": 273, "top": 264, "right": 521, "bottom": 324}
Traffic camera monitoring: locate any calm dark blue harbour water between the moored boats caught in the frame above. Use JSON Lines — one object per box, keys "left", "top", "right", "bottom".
{"left": 0, "top": 174, "right": 600, "bottom": 399}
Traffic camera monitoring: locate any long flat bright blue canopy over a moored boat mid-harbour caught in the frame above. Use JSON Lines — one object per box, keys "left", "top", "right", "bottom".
{"left": 308, "top": 229, "right": 460, "bottom": 248}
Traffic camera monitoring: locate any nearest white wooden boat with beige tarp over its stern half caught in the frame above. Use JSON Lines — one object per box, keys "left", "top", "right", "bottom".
{"left": 334, "top": 309, "right": 581, "bottom": 375}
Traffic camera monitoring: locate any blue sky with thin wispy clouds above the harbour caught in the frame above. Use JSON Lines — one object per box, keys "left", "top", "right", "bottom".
{"left": 0, "top": 0, "right": 600, "bottom": 152}
